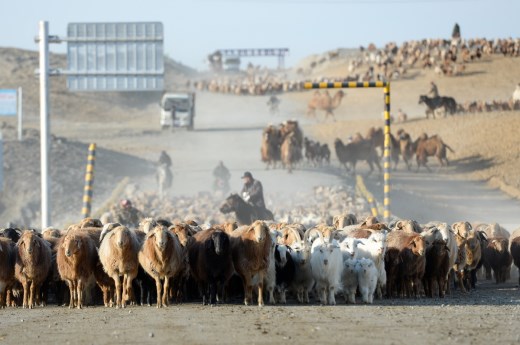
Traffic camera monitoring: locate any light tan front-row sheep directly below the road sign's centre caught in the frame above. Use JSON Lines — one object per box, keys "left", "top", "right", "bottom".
{"left": 98, "top": 226, "right": 140, "bottom": 308}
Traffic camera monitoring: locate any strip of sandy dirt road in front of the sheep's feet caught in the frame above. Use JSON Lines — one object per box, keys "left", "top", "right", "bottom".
{"left": 0, "top": 283, "right": 520, "bottom": 345}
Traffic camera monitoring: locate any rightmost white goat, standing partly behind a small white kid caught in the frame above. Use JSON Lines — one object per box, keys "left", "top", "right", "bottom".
{"left": 356, "top": 231, "right": 387, "bottom": 299}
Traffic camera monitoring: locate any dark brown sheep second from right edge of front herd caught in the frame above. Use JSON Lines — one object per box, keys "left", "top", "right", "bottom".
{"left": 484, "top": 237, "right": 513, "bottom": 284}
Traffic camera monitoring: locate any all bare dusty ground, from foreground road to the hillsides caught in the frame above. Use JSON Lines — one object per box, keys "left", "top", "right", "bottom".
{"left": 0, "top": 49, "right": 520, "bottom": 344}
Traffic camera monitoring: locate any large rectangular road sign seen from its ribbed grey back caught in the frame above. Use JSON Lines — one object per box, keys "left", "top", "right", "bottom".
{"left": 66, "top": 22, "right": 164, "bottom": 91}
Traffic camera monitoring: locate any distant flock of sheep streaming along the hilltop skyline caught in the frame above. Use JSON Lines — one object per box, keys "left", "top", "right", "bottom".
{"left": 190, "top": 38, "right": 520, "bottom": 96}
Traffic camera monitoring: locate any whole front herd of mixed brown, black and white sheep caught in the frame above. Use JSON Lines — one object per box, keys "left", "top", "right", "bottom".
{"left": 0, "top": 210, "right": 520, "bottom": 309}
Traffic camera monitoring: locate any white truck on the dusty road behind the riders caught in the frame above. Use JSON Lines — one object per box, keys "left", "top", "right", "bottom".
{"left": 160, "top": 92, "right": 195, "bottom": 130}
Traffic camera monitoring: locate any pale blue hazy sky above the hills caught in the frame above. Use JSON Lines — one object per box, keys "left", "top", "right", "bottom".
{"left": 0, "top": 0, "right": 520, "bottom": 70}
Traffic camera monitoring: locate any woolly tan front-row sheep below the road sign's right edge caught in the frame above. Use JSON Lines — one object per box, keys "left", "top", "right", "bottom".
{"left": 138, "top": 225, "right": 184, "bottom": 308}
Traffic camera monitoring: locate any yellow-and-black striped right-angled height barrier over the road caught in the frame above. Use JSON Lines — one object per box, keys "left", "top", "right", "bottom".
{"left": 303, "top": 81, "right": 390, "bottom": 222}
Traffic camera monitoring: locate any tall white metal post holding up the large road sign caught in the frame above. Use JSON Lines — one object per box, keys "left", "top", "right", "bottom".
{"left": 39, "top": 21, "right": 51, "bottom": 229}
